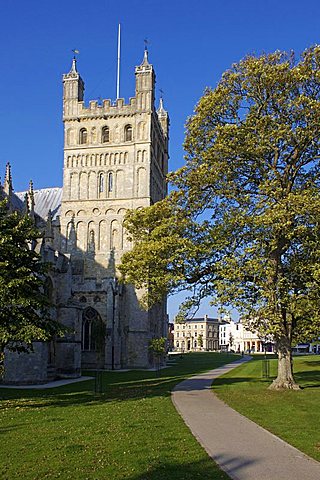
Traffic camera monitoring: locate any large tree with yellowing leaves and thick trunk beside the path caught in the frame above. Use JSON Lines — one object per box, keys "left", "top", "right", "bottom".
{"left": 121, "top": 46, "right": 320, "bottom": 389}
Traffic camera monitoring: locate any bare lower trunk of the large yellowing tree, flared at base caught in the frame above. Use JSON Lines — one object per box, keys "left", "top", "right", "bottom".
{"left": 269, "top": 337, "right": 300, "bottom": 390}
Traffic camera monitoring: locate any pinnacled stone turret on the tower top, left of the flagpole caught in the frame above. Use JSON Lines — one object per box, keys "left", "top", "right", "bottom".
{"left": 63, "top": 57, "right": 84, "bottom": 118}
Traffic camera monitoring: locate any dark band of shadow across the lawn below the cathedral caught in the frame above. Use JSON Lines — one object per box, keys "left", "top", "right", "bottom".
{"left": 0, "top": 353, "right": 239, "bottom": 409}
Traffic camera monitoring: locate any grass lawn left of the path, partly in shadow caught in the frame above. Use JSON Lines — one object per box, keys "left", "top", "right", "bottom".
{"left": 0, "top": 353, "right": 235, "bottom": 480}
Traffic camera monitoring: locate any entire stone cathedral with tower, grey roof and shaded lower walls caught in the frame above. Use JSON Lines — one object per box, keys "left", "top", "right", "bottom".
{"left": 1, "top": 50, "right": 169, "bottom": 383}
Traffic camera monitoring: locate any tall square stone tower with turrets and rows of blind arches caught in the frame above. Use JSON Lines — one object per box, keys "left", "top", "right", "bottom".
{"left": 60, "top": 50, "right": 169, "bottom": 368}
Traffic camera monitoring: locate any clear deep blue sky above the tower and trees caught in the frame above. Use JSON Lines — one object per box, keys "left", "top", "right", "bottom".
{"left": 0, "top": 0, "right": 320, "bottom": 322}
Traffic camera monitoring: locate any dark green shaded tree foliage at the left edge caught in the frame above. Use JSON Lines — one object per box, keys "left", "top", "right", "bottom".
{"left": 0, "top": 201, "right": 62, "bottom": 351}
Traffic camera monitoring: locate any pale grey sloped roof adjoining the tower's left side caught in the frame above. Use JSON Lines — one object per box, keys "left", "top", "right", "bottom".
{"left": 13, "top": 187, "right": 62, "bottom": 220}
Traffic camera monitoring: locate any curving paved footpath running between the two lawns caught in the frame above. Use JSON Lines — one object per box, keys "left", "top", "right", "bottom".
{"left": 172, "top": 357, "right": 320, "bottom": 480}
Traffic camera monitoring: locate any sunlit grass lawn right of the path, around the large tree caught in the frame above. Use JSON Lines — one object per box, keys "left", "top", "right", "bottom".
{"left": 213, "top": 355, "right": 320, "bottom": 461}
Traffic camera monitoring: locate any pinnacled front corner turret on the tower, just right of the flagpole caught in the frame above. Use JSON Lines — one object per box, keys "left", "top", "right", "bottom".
{"left": 135, "top": 49, "right": 156, "bottom": 111}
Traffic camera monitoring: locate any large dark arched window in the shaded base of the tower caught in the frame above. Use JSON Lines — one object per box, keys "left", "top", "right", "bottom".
{"left": 81, "top": 307, "right": 104, "bottom": 352}
